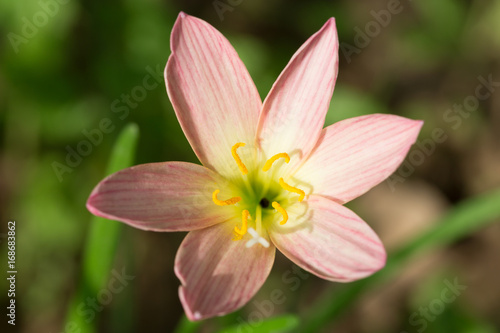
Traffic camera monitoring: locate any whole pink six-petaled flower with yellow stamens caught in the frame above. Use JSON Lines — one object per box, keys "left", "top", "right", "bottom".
{"left": 87, "top": 13, "right": 423, "bottom": 320}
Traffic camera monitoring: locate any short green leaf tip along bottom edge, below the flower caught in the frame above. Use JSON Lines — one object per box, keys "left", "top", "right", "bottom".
{"left": 219, "top": 315, "right": 299, "bottom": 333}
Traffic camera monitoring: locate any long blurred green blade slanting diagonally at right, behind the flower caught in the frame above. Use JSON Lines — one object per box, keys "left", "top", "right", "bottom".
{"left": 300, "top": 189, "right": 500, "bottom": 332}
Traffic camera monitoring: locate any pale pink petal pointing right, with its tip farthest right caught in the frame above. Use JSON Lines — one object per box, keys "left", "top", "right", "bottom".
{"left": 293, "top": 114, "right": 423, "bottom": 203}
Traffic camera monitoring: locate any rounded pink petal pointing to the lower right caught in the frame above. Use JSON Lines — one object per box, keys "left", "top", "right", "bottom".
{"left": 269, "top": 196, "right": 386, "bottom": 282}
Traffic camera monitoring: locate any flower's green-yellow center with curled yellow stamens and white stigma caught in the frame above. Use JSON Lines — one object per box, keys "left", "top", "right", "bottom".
{"left": 212, "top": 142, "right": 305, "bottom": 247}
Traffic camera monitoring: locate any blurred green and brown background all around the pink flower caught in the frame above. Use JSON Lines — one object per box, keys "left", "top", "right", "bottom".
{"left": 0, "top": 0, "right": 500, "bottom": 333}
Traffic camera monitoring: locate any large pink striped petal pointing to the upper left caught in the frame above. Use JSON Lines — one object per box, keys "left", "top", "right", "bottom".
{"left": 165, "top": 13, "right": 262, "bottom": 176}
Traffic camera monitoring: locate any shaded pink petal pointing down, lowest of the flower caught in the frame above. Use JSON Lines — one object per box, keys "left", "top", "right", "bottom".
{"left": 175, "top": 220, "right": 275, "bottom": 320}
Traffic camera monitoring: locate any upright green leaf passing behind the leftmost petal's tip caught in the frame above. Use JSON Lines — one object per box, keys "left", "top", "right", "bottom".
{"left": 64, "top": 124, "right": 139, "bottom": 333}
